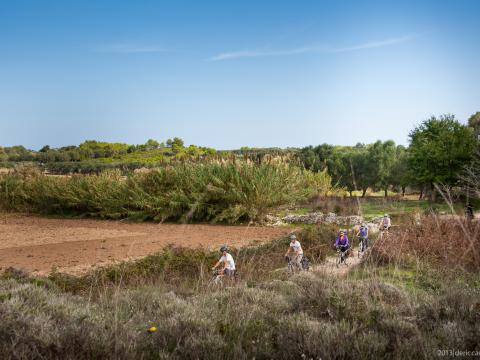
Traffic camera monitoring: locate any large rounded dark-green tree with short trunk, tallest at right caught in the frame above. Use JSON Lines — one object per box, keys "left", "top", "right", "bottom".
{"left": 409, "top": 115, "right": 476, "bottom": 200}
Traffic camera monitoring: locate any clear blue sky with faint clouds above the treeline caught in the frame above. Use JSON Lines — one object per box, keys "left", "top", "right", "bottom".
{"left": 0, "top": 0, "right": 480, "bottom": 149}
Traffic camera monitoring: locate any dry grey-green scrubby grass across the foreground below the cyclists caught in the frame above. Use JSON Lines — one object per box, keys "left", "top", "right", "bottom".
{"left": 0, "top": 268, "right": 480, "bottom": 359}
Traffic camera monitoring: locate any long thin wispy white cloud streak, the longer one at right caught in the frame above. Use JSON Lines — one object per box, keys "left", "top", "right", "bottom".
{"left": 209, "top": 36, "right": 414, "bottom": 61}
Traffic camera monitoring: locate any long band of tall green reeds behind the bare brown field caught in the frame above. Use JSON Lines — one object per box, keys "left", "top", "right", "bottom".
{"left": 0, "top": 162, "right": 330, "bottom": 223}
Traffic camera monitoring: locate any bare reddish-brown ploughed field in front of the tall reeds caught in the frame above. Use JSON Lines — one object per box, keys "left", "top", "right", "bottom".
{"left": 0, "top": 214, "right": 292, "bottom": 274}
